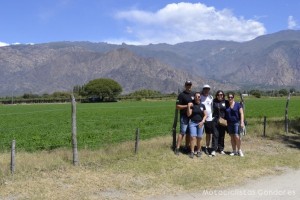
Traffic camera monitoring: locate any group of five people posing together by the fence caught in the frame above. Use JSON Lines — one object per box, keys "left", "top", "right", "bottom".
{"left": 174, "top": 81, "right": 245, "bottom": 158}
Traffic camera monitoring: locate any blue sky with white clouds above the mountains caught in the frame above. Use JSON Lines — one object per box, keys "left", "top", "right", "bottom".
{"left": 0, "top": 0, "right": 300, "bottom": 46}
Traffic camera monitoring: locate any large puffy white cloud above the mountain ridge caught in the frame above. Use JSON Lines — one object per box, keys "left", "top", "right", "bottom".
{"left": 116, "top": 3, "right": 266, "bottom": 44}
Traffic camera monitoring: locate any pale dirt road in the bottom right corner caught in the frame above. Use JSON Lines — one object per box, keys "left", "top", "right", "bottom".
{"left": 147, "top": 170, "right": 300, "bottom": 200}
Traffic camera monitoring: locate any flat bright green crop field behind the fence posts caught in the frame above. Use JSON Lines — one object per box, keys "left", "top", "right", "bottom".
{"left": 0, "top": 97, "right": 300, "bottom": 151}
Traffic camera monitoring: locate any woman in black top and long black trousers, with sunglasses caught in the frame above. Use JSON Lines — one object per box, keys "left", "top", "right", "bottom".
{"left": 211, "top": 90, "right": 229, "bottom": 156}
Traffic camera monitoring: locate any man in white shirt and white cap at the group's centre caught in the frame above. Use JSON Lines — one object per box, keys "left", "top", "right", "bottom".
{"left": 201, "top": 84, "right": 216, "bottom": 156}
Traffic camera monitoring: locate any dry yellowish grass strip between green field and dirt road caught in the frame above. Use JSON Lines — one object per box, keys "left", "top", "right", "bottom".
{"left": 0, "top": 129, "right": 300, "bottom": 200}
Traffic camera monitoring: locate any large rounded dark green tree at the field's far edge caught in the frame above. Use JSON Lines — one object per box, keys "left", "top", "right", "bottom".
{"left": 83, "top": 78, "right": 122, "bottom": 101}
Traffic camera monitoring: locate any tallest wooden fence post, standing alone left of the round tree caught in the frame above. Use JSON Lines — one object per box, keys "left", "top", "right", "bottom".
{"left": 72, "top": 94, "right": 79, "bottom": 166}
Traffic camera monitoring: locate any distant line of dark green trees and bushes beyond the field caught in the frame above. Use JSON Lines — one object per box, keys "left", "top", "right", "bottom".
{"left": 0, "top": 78, "right": 300, "bottom": 103}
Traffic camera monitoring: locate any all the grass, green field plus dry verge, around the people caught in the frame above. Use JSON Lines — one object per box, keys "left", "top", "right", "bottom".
{"left": 0, "top": 98, "right": 300, "bottom": 199}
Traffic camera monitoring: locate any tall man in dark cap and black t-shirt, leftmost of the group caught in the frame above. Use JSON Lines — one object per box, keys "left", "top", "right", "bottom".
{"left": 174, "top": 81, "right": 194, "bottom": 155}
